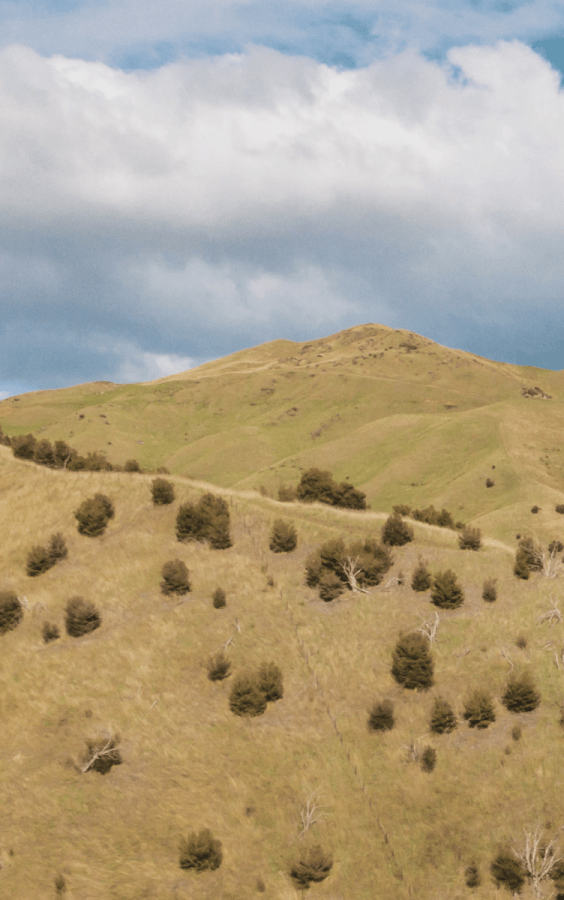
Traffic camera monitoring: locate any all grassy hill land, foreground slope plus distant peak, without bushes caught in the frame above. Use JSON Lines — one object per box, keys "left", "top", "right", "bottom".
{"left": 0, "top": 325, "right": 564, "bottom": 900}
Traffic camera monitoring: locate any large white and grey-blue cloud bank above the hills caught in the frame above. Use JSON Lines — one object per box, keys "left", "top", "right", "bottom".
{"left": 0, "top": 42, "right": 564, "bottom": 380}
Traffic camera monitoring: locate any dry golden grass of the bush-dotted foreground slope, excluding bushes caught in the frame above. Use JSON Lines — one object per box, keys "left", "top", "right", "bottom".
{"left": 0, "top": 448, "right": 564, "bottom": 900}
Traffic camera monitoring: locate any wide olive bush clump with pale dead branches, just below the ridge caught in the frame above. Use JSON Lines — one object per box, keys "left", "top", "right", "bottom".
{"left": 306, "top": 538, "right": 393, "bottom": 600}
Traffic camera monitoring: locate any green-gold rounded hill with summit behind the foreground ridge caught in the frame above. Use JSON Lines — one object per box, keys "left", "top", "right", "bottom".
{"left": 0, "top": 325, "right": 564, "bottom": 540}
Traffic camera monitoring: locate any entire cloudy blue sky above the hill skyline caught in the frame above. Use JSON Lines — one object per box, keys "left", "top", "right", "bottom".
{"left": 0, "top": 0, "right": 564, "bottom": 397}
